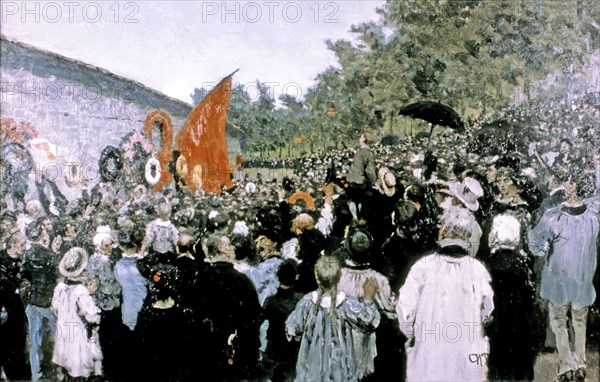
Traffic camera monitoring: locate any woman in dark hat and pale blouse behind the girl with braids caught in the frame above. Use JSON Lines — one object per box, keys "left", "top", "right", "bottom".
{"left": 338, "top": 227, "right": 397, "bottom": 380}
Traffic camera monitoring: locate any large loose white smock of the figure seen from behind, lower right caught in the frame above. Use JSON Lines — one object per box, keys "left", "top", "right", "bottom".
{"left": 396, "top": 254, "right": 494, "bottom": 382}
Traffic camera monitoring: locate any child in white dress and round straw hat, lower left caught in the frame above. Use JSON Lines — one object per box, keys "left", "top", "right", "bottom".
{"left": 52, "top": 247, "right": 102, "bottom": 378}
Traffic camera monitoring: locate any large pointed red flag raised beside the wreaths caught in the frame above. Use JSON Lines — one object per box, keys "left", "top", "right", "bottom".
{"left": 175, "top": 73, "right": 233, "bottom": 194}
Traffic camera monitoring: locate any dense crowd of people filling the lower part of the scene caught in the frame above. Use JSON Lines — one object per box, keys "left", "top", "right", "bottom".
{"left": 0, "top": 93, "right": 600, "bottom": 382}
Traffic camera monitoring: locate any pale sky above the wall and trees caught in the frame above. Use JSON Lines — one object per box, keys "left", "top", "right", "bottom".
{"left": 0, "top": 0, "right": 384, "bottom": 103}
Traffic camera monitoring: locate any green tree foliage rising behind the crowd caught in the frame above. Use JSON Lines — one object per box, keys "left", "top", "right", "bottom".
{"left": 195, "top": 0, "right": 600, "bottom": 156}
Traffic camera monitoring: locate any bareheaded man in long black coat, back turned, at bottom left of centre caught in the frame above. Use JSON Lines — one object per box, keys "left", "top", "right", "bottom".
{"left": 194, "top": 232, "right": 262, "bottom": 381}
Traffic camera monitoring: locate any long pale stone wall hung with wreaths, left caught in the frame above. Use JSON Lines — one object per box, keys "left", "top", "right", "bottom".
{"left": 0, "top": 38, "right": 239, "bottom": 199}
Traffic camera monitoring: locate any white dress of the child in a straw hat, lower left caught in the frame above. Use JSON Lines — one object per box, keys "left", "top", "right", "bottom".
{"left": 52, "top": 282, "right": 102, "bottom": 377}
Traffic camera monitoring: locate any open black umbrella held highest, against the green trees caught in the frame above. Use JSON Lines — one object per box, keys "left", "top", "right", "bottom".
{"left": 398, "top": 101, "right": 465, "bottom": 132}
